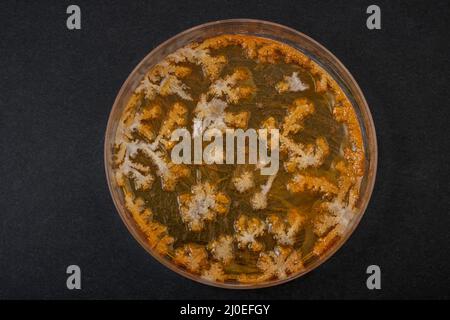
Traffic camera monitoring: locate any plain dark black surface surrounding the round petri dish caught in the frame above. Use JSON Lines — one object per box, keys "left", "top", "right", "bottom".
{"left": 0, "top": 0, "right": 450, "bottom": 299}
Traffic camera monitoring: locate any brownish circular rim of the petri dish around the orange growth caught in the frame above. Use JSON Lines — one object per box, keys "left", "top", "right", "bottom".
{"left": 104, "top": 19, "right": 378, "bottom": 289}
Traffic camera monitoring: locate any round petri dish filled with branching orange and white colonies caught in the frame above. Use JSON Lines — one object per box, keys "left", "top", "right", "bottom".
{"left": 104, "top": 19, "right": 377, "bottom": 289}
